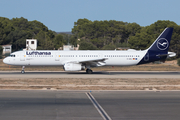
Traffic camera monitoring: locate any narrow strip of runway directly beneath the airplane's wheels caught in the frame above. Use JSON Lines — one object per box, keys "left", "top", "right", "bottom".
{"left": 0, "top": 71, "right": 180, "bottom": 78}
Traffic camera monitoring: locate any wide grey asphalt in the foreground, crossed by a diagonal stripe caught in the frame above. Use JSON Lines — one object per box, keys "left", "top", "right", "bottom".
{"left": 0, "top": 90, "right": 180, "bottom": 120}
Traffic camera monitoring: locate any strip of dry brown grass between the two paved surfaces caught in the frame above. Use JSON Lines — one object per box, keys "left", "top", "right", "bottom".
{"left": 0, "top": 78, "right": 180, "bottom": 90}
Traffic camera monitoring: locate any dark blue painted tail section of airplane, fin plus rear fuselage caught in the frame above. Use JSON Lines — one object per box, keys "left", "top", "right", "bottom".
{"left": 138, "top": 28, "right": 173, "bottom": 64}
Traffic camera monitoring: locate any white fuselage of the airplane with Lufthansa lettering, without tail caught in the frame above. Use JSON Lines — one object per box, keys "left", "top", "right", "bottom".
{"left": 3, "top": 50, "right": 147, "bottom": 66}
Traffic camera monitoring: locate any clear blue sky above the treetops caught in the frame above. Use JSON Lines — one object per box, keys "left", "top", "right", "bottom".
{"left": 0, "top": 0, "right": 180, "bottom": 32}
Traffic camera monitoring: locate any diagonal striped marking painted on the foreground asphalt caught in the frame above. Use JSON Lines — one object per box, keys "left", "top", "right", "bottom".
{"left": 86, "top": 93, "right": 112, "bottom": 120}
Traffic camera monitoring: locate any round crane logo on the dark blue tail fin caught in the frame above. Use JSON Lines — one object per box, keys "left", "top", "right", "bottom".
{"left": 157, "top": 38, "right": 169, "bottom": 50}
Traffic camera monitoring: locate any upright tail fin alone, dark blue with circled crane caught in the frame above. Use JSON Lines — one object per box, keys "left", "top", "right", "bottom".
{"left": 148, "top": 28, "right": 173, "bottom": 53}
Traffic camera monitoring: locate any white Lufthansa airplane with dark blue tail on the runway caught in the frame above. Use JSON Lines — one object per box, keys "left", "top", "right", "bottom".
{"left": 3, "top": 28, "right": 176, "bottom": 74}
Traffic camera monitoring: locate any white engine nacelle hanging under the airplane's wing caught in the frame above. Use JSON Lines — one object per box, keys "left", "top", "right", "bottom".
{"left": 64, "top": 63, "right": 85, "bottom": 71}
